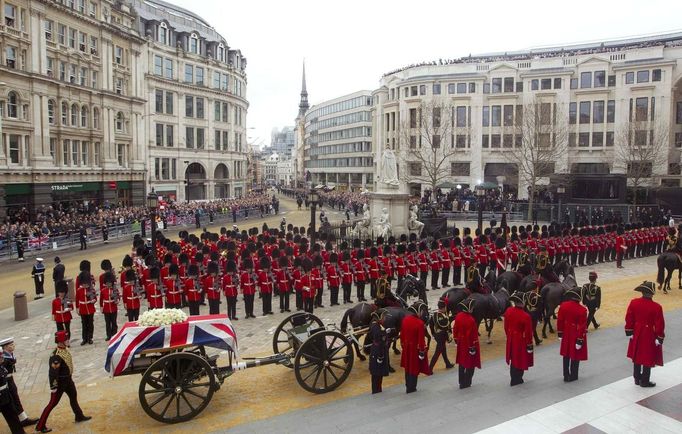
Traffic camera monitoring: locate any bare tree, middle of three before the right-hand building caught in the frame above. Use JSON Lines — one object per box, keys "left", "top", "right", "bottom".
{"left": 503, "top": 98, "right": 568, "bottom": 220}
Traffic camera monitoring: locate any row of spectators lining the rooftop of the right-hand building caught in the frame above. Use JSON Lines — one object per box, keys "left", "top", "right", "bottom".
{"left": 384, "top": 38, "right": 682, "bottom": 77}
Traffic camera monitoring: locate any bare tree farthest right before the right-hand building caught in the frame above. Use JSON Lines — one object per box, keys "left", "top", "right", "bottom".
{"left": 614, "top": 117, "right": 670, "bottom": 206}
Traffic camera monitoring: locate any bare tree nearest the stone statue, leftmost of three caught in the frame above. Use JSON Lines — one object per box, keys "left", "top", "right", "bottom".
{"left": 398, "top": 99, "right": 471, "bottom": 191}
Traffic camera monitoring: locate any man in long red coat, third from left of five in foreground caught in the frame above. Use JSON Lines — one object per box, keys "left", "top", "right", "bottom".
{"left": 504, "top": 291, "right": 533, "bottom": 386}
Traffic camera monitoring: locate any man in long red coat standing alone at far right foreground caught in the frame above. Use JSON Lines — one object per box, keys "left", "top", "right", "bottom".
{"left": 625, "top": 282, "right": 665, "bottom": 387}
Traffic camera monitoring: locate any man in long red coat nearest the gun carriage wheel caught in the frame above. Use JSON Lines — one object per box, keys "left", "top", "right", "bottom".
{"left": 400, "top": 307, "right": 431, "bottom": 393}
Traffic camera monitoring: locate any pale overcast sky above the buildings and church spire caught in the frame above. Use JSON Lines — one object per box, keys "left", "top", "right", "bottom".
{"left": 168, "top": 0, "right": 682, "bottom": 148}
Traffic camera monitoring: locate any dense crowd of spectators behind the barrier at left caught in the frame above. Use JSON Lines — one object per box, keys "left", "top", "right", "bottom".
{"left": 0, "top": 194, "right": 279, "bottom": 246}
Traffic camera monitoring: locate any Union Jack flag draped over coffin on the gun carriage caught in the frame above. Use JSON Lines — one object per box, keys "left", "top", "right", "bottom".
{"left": 104, "top": 315, "right": 238, "bottom": 377}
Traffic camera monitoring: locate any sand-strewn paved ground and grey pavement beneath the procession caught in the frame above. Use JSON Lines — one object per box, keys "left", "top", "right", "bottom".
{"left": 0, "top": 195, "right": 682, "bottom": 432}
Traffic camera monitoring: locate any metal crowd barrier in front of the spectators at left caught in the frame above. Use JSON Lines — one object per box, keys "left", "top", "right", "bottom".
{"left": 0, "top": 207, "right": 268, "bottom": 262}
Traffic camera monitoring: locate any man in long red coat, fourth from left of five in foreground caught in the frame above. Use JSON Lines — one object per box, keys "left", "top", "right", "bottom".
{"left": 557, "top": 289, "right": 587, "bottom": 382}
